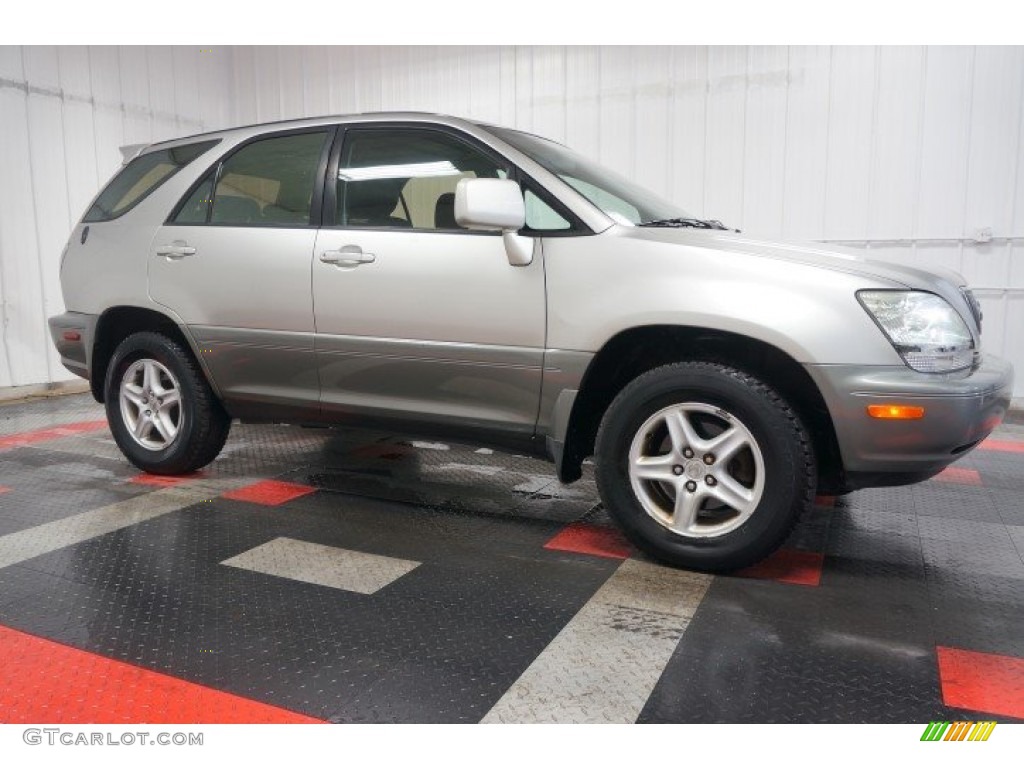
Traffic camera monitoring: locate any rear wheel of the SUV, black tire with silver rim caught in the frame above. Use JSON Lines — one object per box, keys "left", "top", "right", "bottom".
{"left": 103, "top": 332, "right": 230, "bottom": 475}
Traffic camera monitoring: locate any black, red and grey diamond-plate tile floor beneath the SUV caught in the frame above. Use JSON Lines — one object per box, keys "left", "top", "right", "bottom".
{"left": 0, "top": 395, "right": 1024, "bottom": 723}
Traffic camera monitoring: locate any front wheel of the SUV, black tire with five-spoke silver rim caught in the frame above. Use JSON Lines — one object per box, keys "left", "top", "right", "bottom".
{"left": 595, "top": 362, "right": 817, "bottom": 571}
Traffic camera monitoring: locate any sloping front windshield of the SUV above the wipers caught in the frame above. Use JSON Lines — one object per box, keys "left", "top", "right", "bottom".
{"left": 487, "top": 126, "right": 692, "bottom": 224}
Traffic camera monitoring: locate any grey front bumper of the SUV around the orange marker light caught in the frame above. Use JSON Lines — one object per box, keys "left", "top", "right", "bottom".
{"left": 807, "top": 355, "right": 1014, "bottom": 489}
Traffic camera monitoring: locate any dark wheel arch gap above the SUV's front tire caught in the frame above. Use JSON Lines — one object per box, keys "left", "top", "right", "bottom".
{"left": 558, "top": 326, "right": 844, "bottom": 493}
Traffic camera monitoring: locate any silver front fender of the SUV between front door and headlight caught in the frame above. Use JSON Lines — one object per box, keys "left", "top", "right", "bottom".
{"left": 544, "top": 227, "right": 902, "bottom": 366}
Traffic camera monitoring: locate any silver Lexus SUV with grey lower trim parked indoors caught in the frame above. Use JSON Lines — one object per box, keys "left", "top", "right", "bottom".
{"left": 50, "top": 114, "right": 1013, "bottom": 570}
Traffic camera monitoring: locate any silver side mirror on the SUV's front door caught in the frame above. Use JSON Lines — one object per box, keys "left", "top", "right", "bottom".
{"left": 455, "top": 178, "right": 537, "bottom": 266}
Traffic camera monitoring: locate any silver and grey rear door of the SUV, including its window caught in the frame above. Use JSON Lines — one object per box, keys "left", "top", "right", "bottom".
{"left": 150, "top": 127, "right": 335, "bottom": 418}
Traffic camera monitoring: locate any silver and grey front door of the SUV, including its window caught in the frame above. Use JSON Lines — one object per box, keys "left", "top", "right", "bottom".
{"left": 312, "top": 127, "right": 545, "bottom": 434}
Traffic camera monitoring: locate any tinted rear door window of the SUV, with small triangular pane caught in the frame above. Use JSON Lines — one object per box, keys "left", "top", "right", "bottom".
{"left": 200, "top": 131, "right": 328, "bottom": 226}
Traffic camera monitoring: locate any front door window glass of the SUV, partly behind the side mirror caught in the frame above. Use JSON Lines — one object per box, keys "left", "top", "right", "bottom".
{"left": 336, "top": 128, "right": 509, "bottom": 230}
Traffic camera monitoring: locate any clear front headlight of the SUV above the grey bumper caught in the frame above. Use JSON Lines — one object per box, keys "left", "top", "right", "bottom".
{"left": 857, "top": 291, "right": 974, "bottom": 374}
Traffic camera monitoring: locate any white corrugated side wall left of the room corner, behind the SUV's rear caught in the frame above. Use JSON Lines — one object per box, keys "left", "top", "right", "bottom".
{"left": 0, "top": 46, "right": 231, "bottom": 387}
